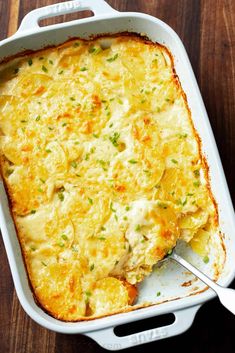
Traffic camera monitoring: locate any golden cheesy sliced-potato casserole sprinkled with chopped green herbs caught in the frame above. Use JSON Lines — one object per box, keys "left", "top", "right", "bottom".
{"left": 0, "top": 34, "right": 218, "bottom": 321}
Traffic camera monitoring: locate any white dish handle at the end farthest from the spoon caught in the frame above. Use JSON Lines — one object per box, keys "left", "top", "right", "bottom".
{"left": 18, "top": 0, "right": 117, "bottom": 32}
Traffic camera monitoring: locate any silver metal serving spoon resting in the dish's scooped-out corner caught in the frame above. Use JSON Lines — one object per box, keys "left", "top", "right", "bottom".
{"left": 167, "top": 250, "right": 235, "bottom": 315}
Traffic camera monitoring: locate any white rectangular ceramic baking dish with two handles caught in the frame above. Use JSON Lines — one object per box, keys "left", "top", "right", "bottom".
{"left": 0, "top": 0, "right": 235, "bottom": 350}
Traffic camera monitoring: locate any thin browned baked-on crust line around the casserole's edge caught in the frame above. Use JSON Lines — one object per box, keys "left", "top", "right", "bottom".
{"left": 0, "top": 32, "right": 222, "bottom": 322}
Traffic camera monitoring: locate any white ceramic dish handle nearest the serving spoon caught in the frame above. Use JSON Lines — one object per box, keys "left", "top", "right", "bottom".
{"left": 85, "top": 305, "right": 200, "bottom": 351}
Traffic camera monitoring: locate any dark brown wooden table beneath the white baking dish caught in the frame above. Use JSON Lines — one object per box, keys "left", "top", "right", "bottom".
{"left": 0, "top": 0, "right": 235, "bottom": 353}
